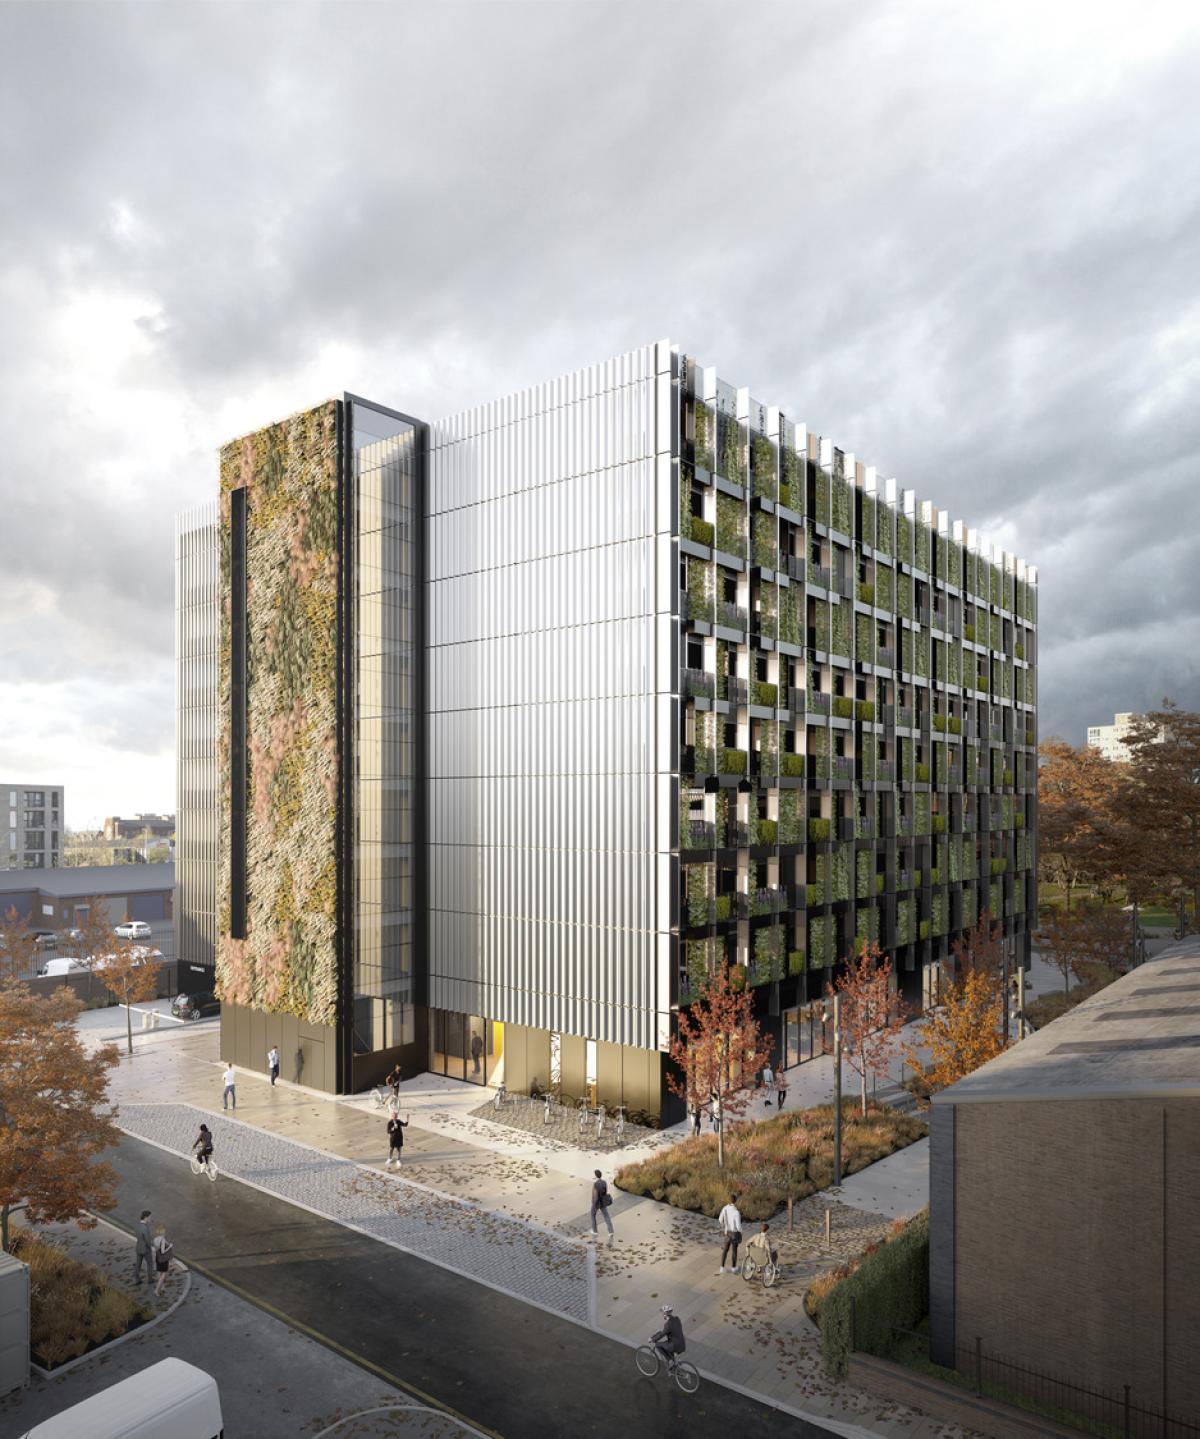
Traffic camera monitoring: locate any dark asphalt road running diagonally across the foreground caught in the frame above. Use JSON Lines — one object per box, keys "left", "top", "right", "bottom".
{"left": 111, "top": 1137, "right": 832, "bottom": 1439}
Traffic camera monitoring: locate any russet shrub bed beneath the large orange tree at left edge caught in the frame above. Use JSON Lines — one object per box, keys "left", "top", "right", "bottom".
{"left": 12, "top": 1229, "right": 154, "bottom": 1368}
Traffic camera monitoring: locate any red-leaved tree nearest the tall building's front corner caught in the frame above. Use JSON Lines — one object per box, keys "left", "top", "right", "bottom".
{"left": 666, "top": 964, "right": 771, "bottom": 1166}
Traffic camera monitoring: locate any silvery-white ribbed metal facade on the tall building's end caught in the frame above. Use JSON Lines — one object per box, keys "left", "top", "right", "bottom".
{"left": 424, "top": 344, "right": 678, "bottom": 1049}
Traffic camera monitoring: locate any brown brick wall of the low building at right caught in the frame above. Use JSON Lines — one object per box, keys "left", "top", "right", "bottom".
{"left": 931, "top": 1098, "right": 1200, "bottom": 1423}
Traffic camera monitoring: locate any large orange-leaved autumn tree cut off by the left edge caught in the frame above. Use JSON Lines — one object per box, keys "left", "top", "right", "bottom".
{"left": 0, "top": 980, "right": 121, "bottom": 1250}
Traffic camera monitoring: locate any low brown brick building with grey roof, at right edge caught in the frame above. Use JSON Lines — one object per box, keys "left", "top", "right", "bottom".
{"left": 929, "top": 940, "right": 1200, "bottom": 1433}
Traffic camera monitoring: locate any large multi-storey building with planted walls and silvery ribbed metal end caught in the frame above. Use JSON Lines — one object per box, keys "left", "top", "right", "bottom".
{"left": 180, "top": 342, "right": 1036, "bottom": 1109}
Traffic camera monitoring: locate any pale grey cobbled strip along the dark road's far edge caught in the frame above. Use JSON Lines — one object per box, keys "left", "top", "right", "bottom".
{"left": 118, "top": 1104, "right": 588, "bottom": 1322}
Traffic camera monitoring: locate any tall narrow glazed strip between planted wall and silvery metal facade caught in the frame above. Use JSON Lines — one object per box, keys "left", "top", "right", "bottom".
{"left": 350, "top": 400, "right": 419, "bottom": 1053}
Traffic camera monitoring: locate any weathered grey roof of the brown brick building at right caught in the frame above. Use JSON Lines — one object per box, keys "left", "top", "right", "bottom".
{"left": 934, "top": 937, "right": 1200, "bottom": 1104}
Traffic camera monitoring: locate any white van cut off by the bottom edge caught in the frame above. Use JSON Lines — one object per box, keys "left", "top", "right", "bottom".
{"left": 22, "top": 1358, "right": 224, "bottom": 1439}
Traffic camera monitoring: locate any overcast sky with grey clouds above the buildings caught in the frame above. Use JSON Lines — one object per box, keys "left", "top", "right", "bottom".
{"left": 0, "top": 0, "right": 1200, "bottom": 826}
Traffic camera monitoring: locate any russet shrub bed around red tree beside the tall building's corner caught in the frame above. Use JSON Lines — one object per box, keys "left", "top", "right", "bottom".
{"left": 616, "top": 1101, "right": 927, "bottom": 1220}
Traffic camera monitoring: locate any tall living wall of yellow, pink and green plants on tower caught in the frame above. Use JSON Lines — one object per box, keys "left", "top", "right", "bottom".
{"left": 216, "top": 401, "right": 340, "bottom": 1025}
